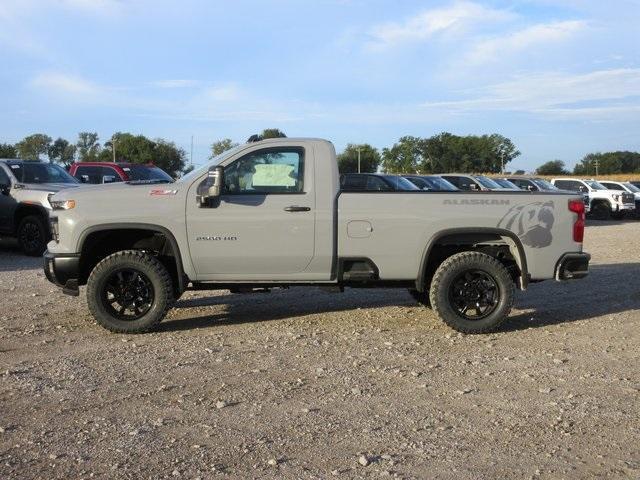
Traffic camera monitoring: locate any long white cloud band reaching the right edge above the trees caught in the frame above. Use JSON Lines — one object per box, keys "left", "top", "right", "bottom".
{"left": 423, "top": 68, "right": 640, "bottom": 117}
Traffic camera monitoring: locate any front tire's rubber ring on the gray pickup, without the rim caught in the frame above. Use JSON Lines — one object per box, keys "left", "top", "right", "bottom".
{"left": 87, "top": 250, "right": 174, "bottom": 333}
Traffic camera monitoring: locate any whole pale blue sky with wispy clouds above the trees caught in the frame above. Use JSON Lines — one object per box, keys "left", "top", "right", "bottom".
{"left": 0, "top": 0, "right": 640, "bottom": 169}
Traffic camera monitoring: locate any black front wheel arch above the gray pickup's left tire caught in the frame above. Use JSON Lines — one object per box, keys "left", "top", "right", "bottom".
{"left": 77, "top": 223, "right": 189, "bottom": 293}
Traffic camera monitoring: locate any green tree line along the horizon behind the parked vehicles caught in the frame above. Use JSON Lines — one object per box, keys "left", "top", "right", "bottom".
{"left": 0, "top": 128, "right": 640, "bottom": 176}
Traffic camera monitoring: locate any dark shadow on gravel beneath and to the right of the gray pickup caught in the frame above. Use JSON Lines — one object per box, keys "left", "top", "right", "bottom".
{"left": 160, "top": 263, "right": 640, "bottom": 332}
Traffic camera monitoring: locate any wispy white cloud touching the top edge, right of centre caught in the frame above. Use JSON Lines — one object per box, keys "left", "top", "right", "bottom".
{"left": 370, "top": 1, "right": 513, "bottom": 47}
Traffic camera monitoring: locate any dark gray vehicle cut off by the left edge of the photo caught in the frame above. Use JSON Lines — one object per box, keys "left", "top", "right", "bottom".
{"left": 0, "top": 160, "right": 78, "bottom": 256}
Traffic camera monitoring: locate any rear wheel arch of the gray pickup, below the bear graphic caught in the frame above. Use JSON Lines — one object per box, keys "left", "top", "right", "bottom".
{"left": 416, "top": 227, "right": 529, "bottom": 292}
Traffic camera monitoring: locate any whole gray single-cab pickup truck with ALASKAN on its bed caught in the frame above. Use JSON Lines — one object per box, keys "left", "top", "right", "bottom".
{"left": 44, "top": 138, "right": 590, "bottom": 333}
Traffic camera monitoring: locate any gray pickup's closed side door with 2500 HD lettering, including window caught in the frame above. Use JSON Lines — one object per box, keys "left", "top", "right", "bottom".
{"left": 187, "top": 146, "right": 315, "bottom": 280}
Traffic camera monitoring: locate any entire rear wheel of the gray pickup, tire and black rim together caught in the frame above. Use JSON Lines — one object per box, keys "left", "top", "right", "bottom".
{"left": 429, "top": 252, "right": 515, "bottom": 333}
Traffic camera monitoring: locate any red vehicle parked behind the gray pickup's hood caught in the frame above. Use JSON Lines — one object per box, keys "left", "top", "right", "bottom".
{"left": 69, "top": 162, "right": 173, "bottom": 184}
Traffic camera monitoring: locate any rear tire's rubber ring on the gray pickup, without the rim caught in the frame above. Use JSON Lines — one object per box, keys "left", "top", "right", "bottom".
{"left": 429, "top": 252, "right": 515, "bottom": 334}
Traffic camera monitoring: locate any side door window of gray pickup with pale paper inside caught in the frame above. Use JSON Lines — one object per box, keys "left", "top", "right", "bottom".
{"left": 224, "top": 148, "right": 304, "bottom": 195}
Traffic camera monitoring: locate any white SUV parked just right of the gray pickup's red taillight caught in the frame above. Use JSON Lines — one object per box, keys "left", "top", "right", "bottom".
{"left": 551, "top": 178, "right": 636, "bottom": 220}
